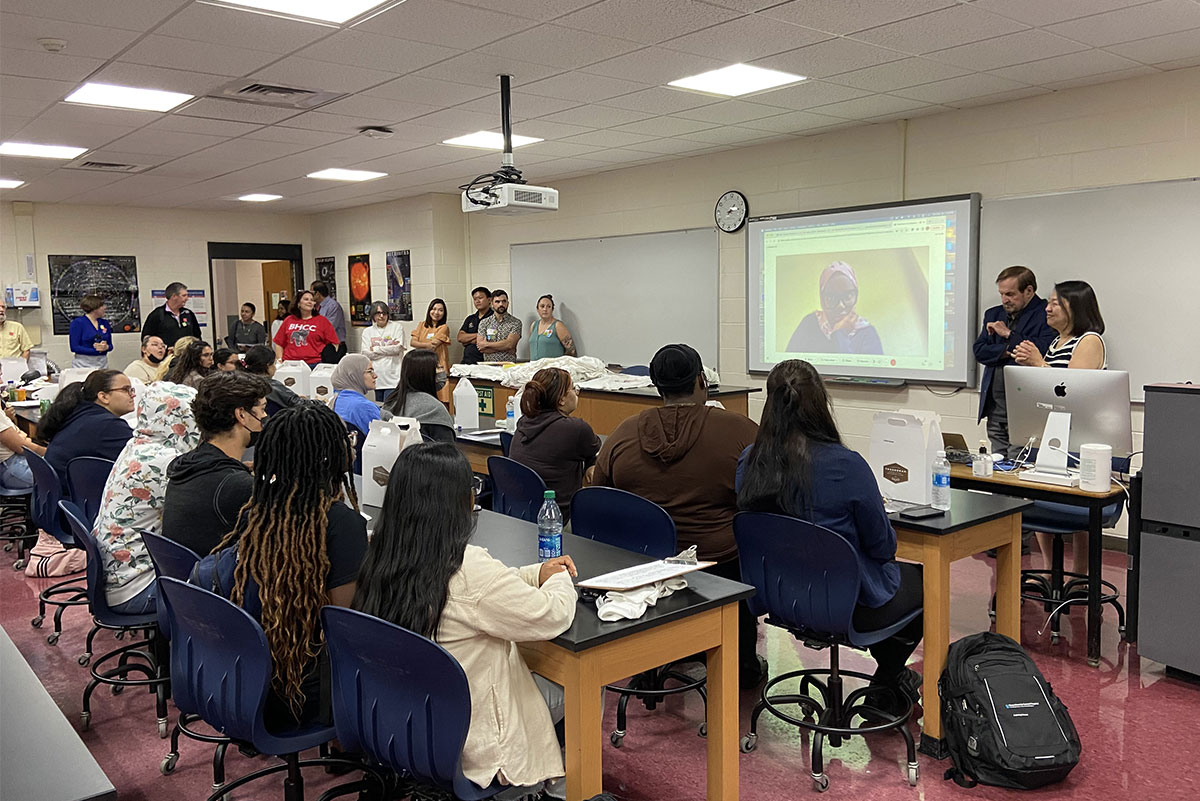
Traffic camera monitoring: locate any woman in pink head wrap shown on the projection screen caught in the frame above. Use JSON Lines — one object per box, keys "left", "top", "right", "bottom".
{"left": 787, "top": 261, "right": 883, "bottom": 354}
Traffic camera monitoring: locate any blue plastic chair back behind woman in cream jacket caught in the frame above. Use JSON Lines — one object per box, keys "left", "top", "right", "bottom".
{"left": 320, "top": 607, "right": 504, "bottom": 801}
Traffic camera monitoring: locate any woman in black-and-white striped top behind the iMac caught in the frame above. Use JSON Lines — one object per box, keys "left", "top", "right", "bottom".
{"left": 1013, "top": 281, "right": 1109, "bottom": 574}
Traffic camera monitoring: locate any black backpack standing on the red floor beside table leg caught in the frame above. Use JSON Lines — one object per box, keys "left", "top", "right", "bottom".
{"left": 937, "top": 632, "right": 1080, "bottom": 790}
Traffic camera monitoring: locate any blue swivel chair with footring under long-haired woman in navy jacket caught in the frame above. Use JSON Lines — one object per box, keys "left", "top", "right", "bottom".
{"left": 733, "top": 512, "right": 916, "bottom": 791}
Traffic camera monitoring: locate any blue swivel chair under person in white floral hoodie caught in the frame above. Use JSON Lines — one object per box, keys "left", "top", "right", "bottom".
{"left": 59, "top": 501, "right": 170, "bottom": 737}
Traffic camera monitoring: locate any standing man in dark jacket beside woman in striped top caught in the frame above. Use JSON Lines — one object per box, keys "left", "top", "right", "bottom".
{"left": 974, "top": 265, "right": 1056, "bottom": 458}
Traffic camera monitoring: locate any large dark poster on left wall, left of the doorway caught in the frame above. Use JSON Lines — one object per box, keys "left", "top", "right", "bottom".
{"left": 48, "top": 255, "right": 142, "bottom": 337}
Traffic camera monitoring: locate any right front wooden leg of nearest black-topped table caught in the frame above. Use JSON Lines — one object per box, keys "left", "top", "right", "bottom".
{"left": 708, "top": 603, "right": 738, "bottom": 801}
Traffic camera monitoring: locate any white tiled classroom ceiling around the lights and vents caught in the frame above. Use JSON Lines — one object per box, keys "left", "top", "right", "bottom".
{"left": 0, "top": 0, "right": 1200, "bottom": 213}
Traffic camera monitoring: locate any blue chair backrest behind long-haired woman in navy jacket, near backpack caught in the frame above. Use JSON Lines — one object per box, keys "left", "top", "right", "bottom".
{"left": 733, "top": 512, "right": 860, "bottom": 642}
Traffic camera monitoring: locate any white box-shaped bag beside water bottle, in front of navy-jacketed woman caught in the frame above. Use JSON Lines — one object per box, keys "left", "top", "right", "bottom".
{"left": 868, "top": 411, "right": 944, "bottom": 504}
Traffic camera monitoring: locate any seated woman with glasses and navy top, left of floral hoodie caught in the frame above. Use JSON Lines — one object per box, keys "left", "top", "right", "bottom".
{"left": 37, "top": 369, "right": 134, "bottom": 496}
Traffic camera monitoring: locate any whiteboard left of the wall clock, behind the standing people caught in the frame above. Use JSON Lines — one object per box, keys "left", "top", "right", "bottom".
{"left": 509, "top": 228, "right": 720, "bottom": 367}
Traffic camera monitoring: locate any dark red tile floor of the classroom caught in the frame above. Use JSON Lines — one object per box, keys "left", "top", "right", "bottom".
{"left": 0, "top": 544, "right": 1200, "bottom": 801}
